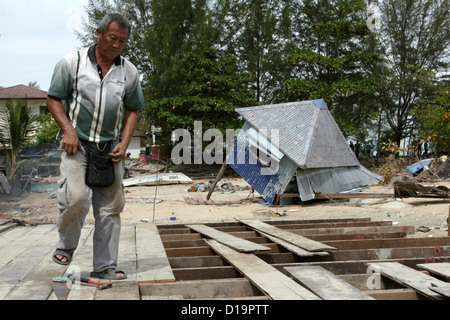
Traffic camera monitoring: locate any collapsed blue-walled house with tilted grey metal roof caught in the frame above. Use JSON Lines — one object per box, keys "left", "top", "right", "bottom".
{"left": 225, "top": 99, "right": 382, "bottom": 203}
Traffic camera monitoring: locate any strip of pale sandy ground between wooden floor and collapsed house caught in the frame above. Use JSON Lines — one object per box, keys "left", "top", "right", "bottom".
{"left": 0, "top": 162, "right": 450, "bottom": 237}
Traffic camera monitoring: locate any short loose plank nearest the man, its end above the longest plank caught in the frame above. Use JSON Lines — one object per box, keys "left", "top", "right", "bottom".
{"left": 187, "top": 224, "right": 270, "bottom": 252}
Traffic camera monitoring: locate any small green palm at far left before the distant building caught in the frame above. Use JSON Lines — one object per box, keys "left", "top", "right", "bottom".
{"left": 0, "top": 99, "right": 37, "bottom": 181}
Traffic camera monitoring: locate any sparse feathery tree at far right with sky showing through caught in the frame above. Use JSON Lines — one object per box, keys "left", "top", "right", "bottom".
{"left": 379, "top": 0, "right": 450, "bottom": 143}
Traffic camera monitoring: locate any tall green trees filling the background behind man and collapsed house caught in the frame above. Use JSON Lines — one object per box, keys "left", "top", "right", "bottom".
{"left": 72, "top": 0, "right": 450, "bottom": 156}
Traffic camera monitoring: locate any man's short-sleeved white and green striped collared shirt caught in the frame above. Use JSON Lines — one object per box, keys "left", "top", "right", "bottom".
{"left": 48, "top": 46, "right": 145, "bottom": 142}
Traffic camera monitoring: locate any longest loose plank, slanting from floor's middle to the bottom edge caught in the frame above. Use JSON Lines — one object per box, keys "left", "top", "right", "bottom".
{"left": 205, "top": 240, "right": 319, "bottom": 300}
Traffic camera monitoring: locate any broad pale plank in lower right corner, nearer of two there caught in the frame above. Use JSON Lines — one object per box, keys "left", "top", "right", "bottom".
{"left": 367, "top": 262, "right": 448, "bottom": 299}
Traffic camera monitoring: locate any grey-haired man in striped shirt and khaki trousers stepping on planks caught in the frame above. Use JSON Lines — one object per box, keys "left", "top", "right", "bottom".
{"left": 47, "top": 13, "right": 144, "bottom": 280}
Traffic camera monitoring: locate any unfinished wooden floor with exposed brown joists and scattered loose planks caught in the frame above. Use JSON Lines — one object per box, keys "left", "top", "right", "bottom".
{"left": 0, "top": 218, "right": 450, "bottom": 300}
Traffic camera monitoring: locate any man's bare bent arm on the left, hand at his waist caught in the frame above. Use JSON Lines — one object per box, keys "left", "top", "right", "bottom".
{"left": 47, "top": 96, "right": 81, "bottom": 154}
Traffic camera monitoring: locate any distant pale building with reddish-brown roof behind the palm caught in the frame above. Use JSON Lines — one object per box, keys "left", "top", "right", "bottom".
{"left": 0, "top": 84, "right": 47, "bottom": 115}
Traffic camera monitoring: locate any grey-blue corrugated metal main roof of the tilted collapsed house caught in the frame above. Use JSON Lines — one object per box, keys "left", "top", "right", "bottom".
{"left": 236, "top": 100, "right": 359, "bottom": 169}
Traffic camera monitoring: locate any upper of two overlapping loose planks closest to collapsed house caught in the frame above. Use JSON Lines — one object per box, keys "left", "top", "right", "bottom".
{"left": 240, "top": 220, "right": 336, "bottom": 252}
